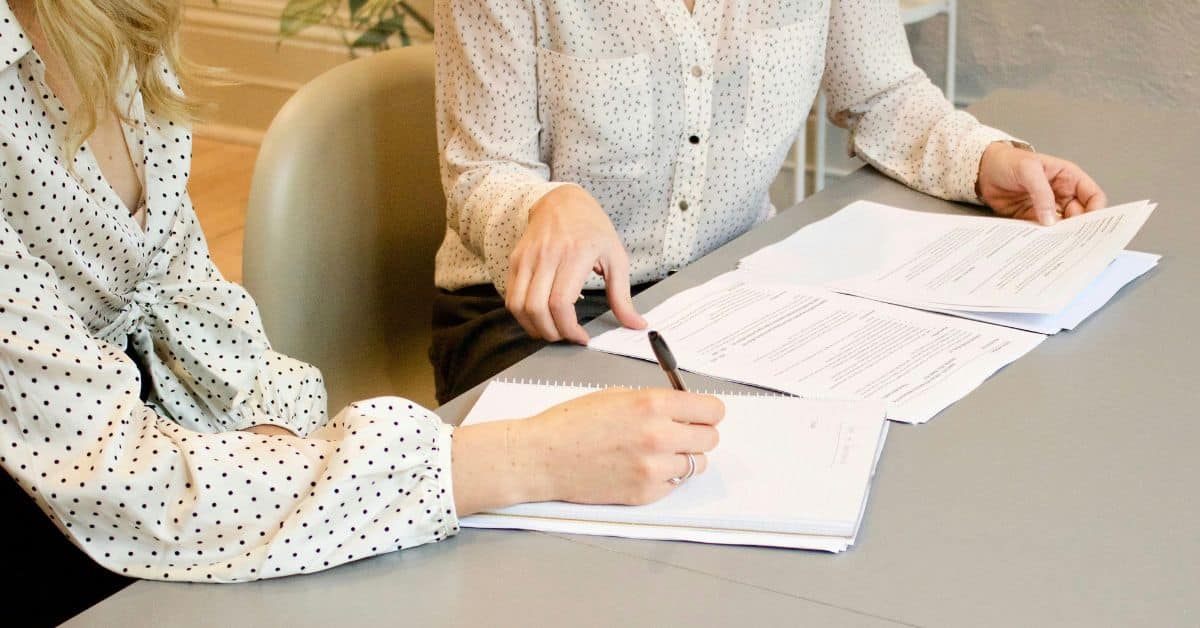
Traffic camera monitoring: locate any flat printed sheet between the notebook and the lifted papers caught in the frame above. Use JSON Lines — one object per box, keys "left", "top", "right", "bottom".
{"left": 588, "top": 269, "right": 1045, "bottom": 423}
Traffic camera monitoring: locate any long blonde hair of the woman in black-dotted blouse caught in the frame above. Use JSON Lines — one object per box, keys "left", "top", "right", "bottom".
{"left": 35, "top": 0, "right": 205, "bottom": 159}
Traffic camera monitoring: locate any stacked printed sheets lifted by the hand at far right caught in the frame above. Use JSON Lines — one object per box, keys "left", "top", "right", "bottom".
{"left": 739, "top": 201, "right": 1158, "bottom": 334}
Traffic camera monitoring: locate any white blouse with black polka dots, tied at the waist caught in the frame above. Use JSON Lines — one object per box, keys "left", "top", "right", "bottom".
{"left": 0, "top": 9, "right": 457, "bottom": 581}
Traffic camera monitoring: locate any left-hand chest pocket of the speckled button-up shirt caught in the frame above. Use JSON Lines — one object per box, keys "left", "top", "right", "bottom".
{"left": 538, "top": 48, "right": 654, "bottom": 180}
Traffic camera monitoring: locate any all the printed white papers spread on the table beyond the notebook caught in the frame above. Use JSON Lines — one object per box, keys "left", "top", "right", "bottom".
{"left": 588, "top": 202, "right": 1158, "bottom": 423}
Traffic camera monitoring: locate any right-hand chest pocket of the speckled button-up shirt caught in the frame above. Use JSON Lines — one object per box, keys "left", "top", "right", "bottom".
{"left": 743, "top": 17, "right": 826, "bottom": 160}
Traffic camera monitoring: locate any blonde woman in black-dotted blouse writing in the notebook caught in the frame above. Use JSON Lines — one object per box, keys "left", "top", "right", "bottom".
{"left": 0, "top": 0, "right": 724, "bottom": 621}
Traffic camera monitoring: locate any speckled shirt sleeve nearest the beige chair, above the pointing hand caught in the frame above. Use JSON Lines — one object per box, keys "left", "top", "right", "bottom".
{"left": 434, "top": 0, "right": 563, "bottom": 292}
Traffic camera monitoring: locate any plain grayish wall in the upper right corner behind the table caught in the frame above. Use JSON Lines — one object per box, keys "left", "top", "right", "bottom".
{"left": 908, "top": 0, "right": 1200, "bottom": 108}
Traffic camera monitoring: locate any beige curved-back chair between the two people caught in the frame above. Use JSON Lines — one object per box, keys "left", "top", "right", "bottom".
{"left": 242, "top": 46, "right": 445, "bottom": 412}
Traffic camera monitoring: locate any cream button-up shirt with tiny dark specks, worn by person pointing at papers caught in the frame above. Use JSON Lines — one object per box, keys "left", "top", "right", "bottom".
{"left": 436, "top": 0, "right": 1010, "bottom": 291}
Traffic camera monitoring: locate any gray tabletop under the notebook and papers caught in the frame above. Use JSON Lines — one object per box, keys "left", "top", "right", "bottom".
{"left": 70, "top": 90, "right": 1200, "bottom": 627}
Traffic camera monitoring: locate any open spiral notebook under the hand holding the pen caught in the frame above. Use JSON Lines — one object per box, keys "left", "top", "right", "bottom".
{"left": 461, "top": 381, "right": 888, "bottom": 551}
